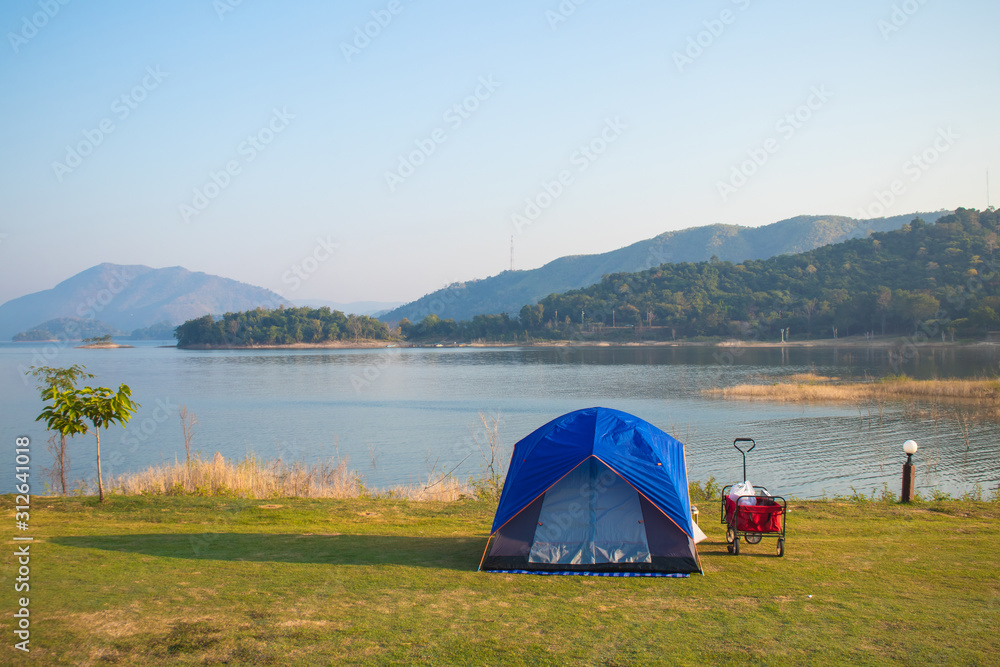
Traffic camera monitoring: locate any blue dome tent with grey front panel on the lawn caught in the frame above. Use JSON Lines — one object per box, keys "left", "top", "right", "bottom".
{"left": 480, "top": 408, "right": 701, "bottom": 576}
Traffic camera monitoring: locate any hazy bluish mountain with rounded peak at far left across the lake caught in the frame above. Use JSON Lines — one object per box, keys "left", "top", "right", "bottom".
{"left": 0, "top": 263, "right": 292, "bottom": 340}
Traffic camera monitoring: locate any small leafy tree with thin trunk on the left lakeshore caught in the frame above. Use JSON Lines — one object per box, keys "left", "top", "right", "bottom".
{"left": 35, "top": 384, "right": 139, "bottom": 503}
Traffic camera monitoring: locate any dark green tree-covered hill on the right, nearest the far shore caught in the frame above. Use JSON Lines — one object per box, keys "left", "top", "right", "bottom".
{"left": 402, "top": 209, "right": 1000, "bottom": 340}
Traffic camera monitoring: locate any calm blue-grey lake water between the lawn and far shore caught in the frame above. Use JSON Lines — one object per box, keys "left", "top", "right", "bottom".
{"left": 0, "top": 342, "right": 1000, "bottom": 497}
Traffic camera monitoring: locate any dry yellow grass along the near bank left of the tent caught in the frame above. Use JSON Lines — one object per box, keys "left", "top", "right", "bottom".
{"left": 110, "top": 452, "right": 474, "bottom": 501}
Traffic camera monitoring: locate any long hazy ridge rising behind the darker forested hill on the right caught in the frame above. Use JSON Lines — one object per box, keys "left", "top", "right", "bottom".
{"left": 379, "top": 211, "right": 948, "bottom": 323}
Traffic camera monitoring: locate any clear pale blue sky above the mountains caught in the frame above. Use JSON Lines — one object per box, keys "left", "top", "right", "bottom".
{"left": 0, "top": 0, "right": 1000, "bottom": 302}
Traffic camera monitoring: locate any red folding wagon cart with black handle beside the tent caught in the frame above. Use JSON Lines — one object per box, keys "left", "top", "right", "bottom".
{"left": 721, "top": 438, "right": 788, "bottom": 557}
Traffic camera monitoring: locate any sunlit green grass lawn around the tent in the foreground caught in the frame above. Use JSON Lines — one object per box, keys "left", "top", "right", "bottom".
{"left": 0, "top": 496, "right": 1000, "bottom": 665}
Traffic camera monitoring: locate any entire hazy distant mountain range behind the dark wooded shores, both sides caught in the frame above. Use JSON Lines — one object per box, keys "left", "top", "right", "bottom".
{"left": 0, "top": 211, "right": 949, "bottom": 340}
